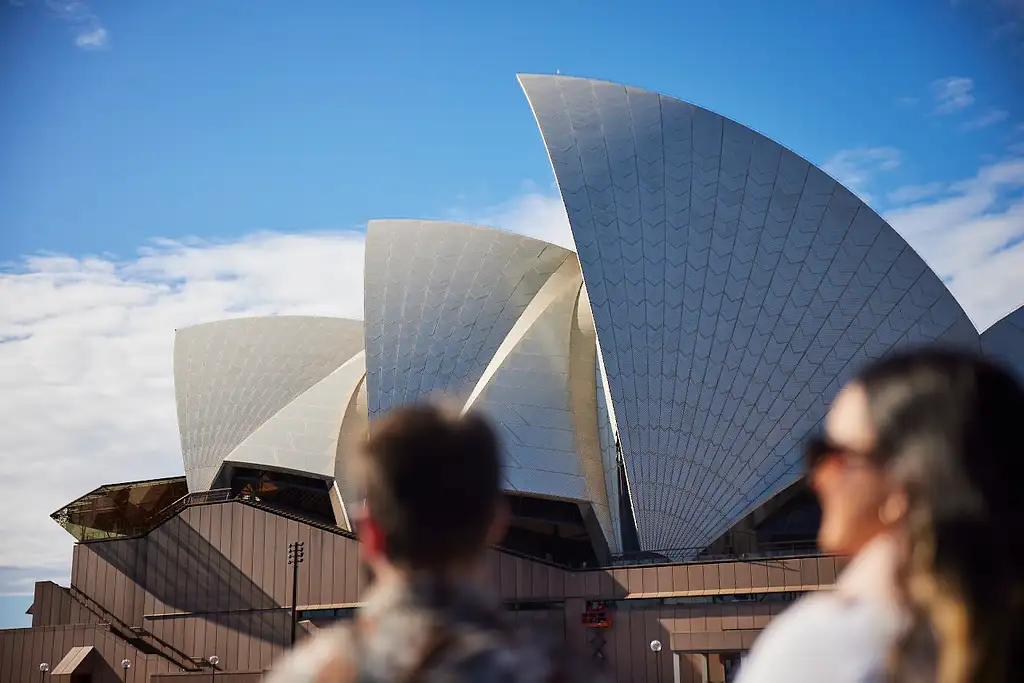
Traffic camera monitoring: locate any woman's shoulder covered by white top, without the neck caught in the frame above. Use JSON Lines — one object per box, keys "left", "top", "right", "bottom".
{"left": 739, "top": 592, "right": 898, "bottom": 683}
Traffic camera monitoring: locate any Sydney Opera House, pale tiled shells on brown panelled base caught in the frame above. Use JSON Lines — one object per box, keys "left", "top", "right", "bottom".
{"left": 0, "top": 76, "right": 1024, "bottom": 683}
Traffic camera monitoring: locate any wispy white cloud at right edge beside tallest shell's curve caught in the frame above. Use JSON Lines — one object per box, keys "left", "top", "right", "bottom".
{"left": 886, "top": 158, "right": 1024, "bottom": 330}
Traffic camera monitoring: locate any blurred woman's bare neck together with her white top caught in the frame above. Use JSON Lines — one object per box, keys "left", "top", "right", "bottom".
{"left": 737, "top": 537, "right": 902, "bottom": 683}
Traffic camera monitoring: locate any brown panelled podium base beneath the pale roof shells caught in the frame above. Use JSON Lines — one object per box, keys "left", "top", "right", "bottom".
{"left": 0, "top": 479, "right": 839, "bottom": 683}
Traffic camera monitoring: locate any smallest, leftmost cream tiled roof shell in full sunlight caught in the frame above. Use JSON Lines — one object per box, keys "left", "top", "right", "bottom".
{"left": 174, "top": 315, "right": 366, "bottom": 492}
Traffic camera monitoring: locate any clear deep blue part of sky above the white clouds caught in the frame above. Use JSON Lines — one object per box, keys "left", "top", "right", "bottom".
{"left": 0, "top": 0, "right": 1024, "bottom": 259}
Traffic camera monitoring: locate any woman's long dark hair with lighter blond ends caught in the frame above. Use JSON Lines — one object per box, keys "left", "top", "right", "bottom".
{"left": 859, "top": 349, "right": 1024, "bottom": 683}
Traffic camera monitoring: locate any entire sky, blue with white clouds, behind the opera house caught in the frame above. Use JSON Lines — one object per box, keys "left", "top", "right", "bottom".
{"left": 0, "top": 0, "right": 1024, "bottom": 627}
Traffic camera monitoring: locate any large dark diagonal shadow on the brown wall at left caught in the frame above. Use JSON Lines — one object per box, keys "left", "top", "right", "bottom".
{"left": 90, "top": 516, "right": 290, "bottom": 645}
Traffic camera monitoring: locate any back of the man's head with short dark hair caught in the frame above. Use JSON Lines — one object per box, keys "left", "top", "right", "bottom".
{"left": 358, "top": 404, "right": 502, "bottom": 569}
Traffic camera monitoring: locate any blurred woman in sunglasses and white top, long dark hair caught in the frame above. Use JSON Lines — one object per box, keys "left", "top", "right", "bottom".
{"left": 739, "top": 349, "right": 1024, "bottom": 683}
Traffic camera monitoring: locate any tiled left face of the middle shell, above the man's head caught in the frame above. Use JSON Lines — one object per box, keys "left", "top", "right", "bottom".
{"left": 364, "top": 220, "right": 574, "bottom": 418}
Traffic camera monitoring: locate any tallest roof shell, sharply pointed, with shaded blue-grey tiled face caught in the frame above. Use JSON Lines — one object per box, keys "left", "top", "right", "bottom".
{"left": 520, "top": 76, "right": 978, "bottom": 554}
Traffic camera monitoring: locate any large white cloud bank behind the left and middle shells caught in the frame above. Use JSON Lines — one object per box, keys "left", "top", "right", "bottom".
{"left": 0, "top": 193, "right": 568, "bottom": 595}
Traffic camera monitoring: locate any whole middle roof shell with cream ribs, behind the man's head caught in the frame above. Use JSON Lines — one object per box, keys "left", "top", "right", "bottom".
{"left": 365, "top": 220, "right": 618, "bottom": 551}
